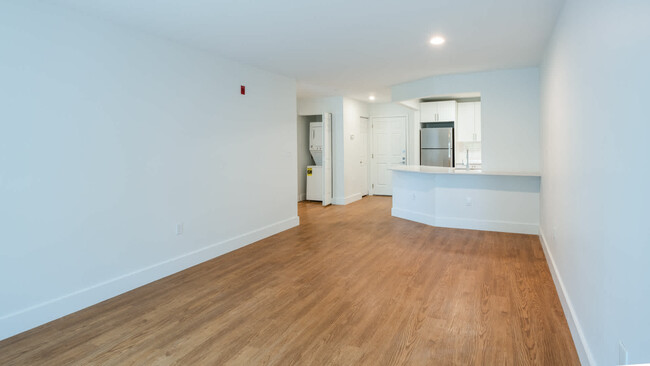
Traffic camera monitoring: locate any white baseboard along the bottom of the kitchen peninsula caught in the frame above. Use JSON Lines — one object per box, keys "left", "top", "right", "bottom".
{"left": 391, "top": 207, "right": 539, "bottom": 235}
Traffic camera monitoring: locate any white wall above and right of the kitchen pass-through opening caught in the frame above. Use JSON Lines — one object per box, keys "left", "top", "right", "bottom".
{"left": 391, "top": 68, "right": 540, "bottom": 172}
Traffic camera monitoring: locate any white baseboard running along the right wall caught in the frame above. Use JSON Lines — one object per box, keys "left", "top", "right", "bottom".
{"left": 539, "top": 227, "right": 596, "bottom": 366}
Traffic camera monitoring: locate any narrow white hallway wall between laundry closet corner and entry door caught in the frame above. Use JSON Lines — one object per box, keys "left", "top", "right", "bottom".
{"left": 339, "top": 98, "right": 369, "bottom": 204}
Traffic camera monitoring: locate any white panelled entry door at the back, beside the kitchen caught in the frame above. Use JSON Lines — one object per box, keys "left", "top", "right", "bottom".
{"left": 370, "top": 116, "right": 406, "bottom": 196}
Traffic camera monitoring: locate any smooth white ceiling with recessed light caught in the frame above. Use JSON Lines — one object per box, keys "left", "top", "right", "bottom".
{"left": 55, "top": 0, "right": 564, "bottom": 102}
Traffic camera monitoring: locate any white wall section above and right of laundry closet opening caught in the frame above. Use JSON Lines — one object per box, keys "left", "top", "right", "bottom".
{"left": 298, "top": 97, "right": 345, "bottom": 204}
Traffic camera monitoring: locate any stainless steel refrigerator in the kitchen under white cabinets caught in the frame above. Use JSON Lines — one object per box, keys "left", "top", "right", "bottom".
{"left": 420, "top": 122, "right": 454, "bottom": 167}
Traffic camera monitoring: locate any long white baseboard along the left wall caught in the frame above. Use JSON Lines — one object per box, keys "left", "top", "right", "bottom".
{"left": 0, "top": 216, "right": 300, "bottom": 340}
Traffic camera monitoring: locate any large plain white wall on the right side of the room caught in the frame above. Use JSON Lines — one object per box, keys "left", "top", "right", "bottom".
{"left": 541, "top": 0, "right": 650, "bottom": 365}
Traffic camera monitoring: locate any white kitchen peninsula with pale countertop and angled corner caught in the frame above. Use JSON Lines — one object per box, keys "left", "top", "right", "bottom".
{"left": 391, "top": 165, "right": 541, "bottom": 234}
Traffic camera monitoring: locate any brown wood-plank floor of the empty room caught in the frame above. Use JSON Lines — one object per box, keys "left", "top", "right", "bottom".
{"left": 0, "top": 197, "right": 579, "bottom": 365}
